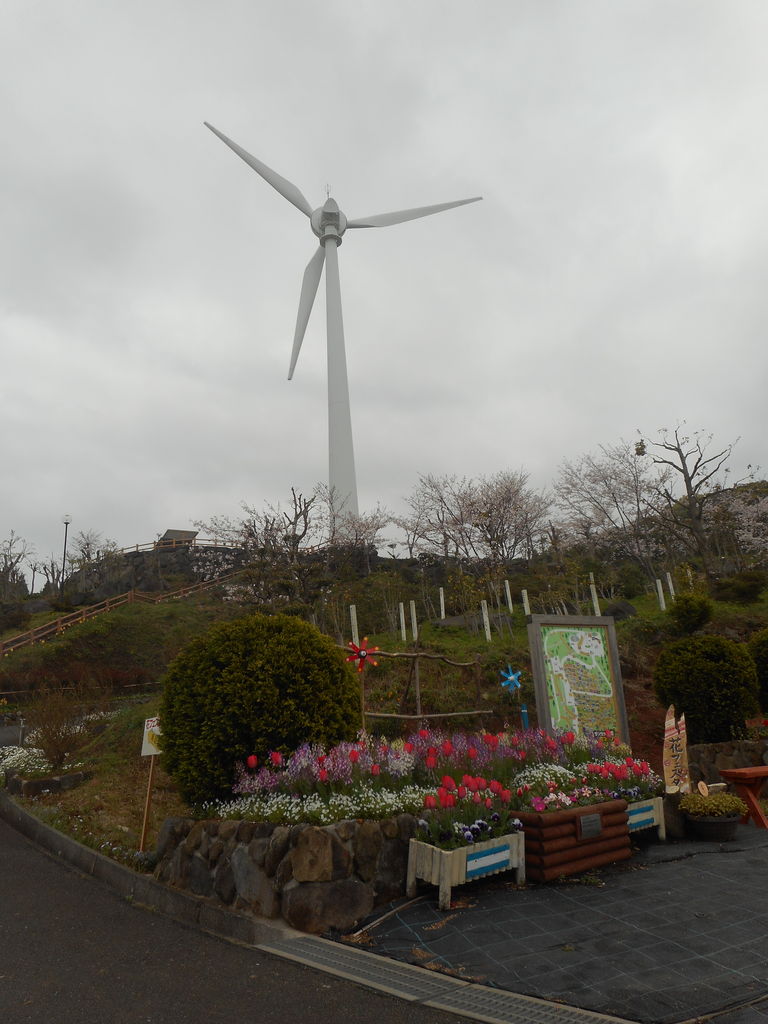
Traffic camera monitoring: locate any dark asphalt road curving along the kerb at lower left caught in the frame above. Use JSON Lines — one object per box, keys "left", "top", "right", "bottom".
{"left": 0, "top": 821, "right": 466, "bottom": 1024}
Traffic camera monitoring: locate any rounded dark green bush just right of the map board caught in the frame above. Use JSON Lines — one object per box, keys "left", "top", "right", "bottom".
{"left": 653, "top": 636, "right": 759, "bottom": 743}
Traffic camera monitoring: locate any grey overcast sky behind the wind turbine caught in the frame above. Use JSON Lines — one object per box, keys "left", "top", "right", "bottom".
{"left": 0, "top": 0, "right": 768, "bottom": 569}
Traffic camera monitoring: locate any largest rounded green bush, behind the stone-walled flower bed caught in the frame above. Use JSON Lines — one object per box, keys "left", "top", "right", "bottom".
{"left": 161, "top": 615, "right": 360, "bottom": 805}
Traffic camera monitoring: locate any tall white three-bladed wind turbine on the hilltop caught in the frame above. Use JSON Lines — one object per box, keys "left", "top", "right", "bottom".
{"left": 204, "top": 121, "right": 482, "bottom": 516}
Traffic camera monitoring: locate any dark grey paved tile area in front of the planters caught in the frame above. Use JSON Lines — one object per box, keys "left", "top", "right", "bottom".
{"left": 344, "top": 825, "right": 768, "bottom": 1024}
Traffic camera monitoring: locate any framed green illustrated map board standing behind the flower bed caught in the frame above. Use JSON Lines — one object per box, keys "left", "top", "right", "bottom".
{"left": 527, "top": 615, "right": 629, "bottom": 743}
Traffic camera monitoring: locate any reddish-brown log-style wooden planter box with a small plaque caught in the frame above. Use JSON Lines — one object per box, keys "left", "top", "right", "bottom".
{"left": 517, "top": 800, "right": 632, "bottom": 882}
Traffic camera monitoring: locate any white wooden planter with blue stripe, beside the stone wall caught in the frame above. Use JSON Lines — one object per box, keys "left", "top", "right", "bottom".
{"left": 406, "top": 833, "right": 525, "bottom": 910}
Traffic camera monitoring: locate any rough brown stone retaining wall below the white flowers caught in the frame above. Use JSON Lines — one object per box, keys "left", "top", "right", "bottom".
{"left": 155, "top": 814, "right": 416, "bottom": 934}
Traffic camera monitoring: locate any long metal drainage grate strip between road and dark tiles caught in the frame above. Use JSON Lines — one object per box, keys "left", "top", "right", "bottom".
{"left": 258, "top": 936, "right": 629, "bottom": 1024}
